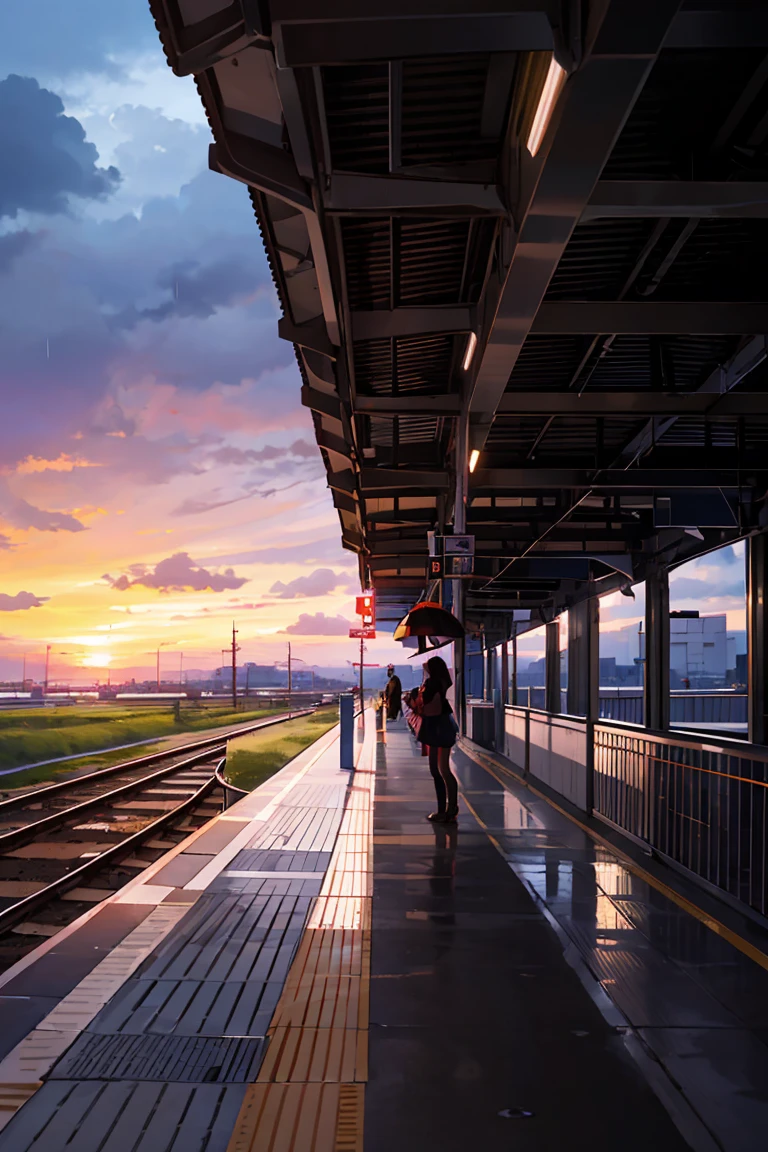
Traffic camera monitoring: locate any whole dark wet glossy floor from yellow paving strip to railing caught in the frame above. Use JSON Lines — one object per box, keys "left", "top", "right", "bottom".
{"left": 365, "top": 725, "right": 768, "bottom": 1152}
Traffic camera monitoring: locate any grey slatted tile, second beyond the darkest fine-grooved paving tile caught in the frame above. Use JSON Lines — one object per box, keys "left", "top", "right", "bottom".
{"left": 138, "top": 892, "right": 311, "bottom": 980}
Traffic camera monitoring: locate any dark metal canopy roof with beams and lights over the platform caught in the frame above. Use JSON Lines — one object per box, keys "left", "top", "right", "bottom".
{"left": 150, "top": 0, "right": 768, "bottom": 631}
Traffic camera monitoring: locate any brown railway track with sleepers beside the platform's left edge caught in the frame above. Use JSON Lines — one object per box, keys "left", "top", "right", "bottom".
{"left": 0, "top": 715, "right": 313, "bottom": 971}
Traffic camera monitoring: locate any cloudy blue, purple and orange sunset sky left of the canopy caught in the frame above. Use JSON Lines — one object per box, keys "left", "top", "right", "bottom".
{"left": 0, "top": 0, "right": 403, "bottom": 679}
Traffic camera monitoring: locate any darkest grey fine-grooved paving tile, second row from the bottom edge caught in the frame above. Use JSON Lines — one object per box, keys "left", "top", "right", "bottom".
{"left": 47, "top": 1033, "right": 266, "bottom": 1084}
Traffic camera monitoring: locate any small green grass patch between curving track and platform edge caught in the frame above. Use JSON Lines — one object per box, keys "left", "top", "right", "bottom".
{"left": 225, "top": 707, "right": 339, "bottom": 791}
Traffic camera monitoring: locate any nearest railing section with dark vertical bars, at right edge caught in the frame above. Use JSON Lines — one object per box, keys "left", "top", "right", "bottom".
{"left": 593, "top": 723, "right": 768, "bottom": 916}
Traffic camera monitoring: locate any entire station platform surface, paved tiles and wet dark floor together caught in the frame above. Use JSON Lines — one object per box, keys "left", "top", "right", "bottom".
{"left": 0, "top": 715, "right": 768, "bottom": 1152}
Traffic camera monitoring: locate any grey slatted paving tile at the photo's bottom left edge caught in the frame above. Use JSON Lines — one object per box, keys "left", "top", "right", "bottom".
{"left": 0, "top": 1081, "right": 245, "bottom": 1152}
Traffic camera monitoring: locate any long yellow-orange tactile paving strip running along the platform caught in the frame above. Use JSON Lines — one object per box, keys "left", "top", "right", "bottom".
{"left": 227, "top": 718, "right": 375, "bottom": 1152}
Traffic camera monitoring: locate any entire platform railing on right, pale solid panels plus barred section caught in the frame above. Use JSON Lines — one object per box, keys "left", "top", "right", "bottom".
{"left": 496, "top": 705, "right": 768, "bottom": 917}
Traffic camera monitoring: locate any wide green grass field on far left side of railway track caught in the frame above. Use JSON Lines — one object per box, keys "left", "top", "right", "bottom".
{"left": 0, "top": 704, "right": 279, "bottom": 788}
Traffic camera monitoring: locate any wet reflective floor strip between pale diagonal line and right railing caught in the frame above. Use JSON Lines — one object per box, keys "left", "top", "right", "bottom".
{"left": 456, "top": 752, "right": 768, "bottom": 1152}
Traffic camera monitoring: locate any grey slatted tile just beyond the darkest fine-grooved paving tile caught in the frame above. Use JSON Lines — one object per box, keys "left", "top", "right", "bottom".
{"left": 89, "top": 980, "right": 282, "bottom": 1037}
